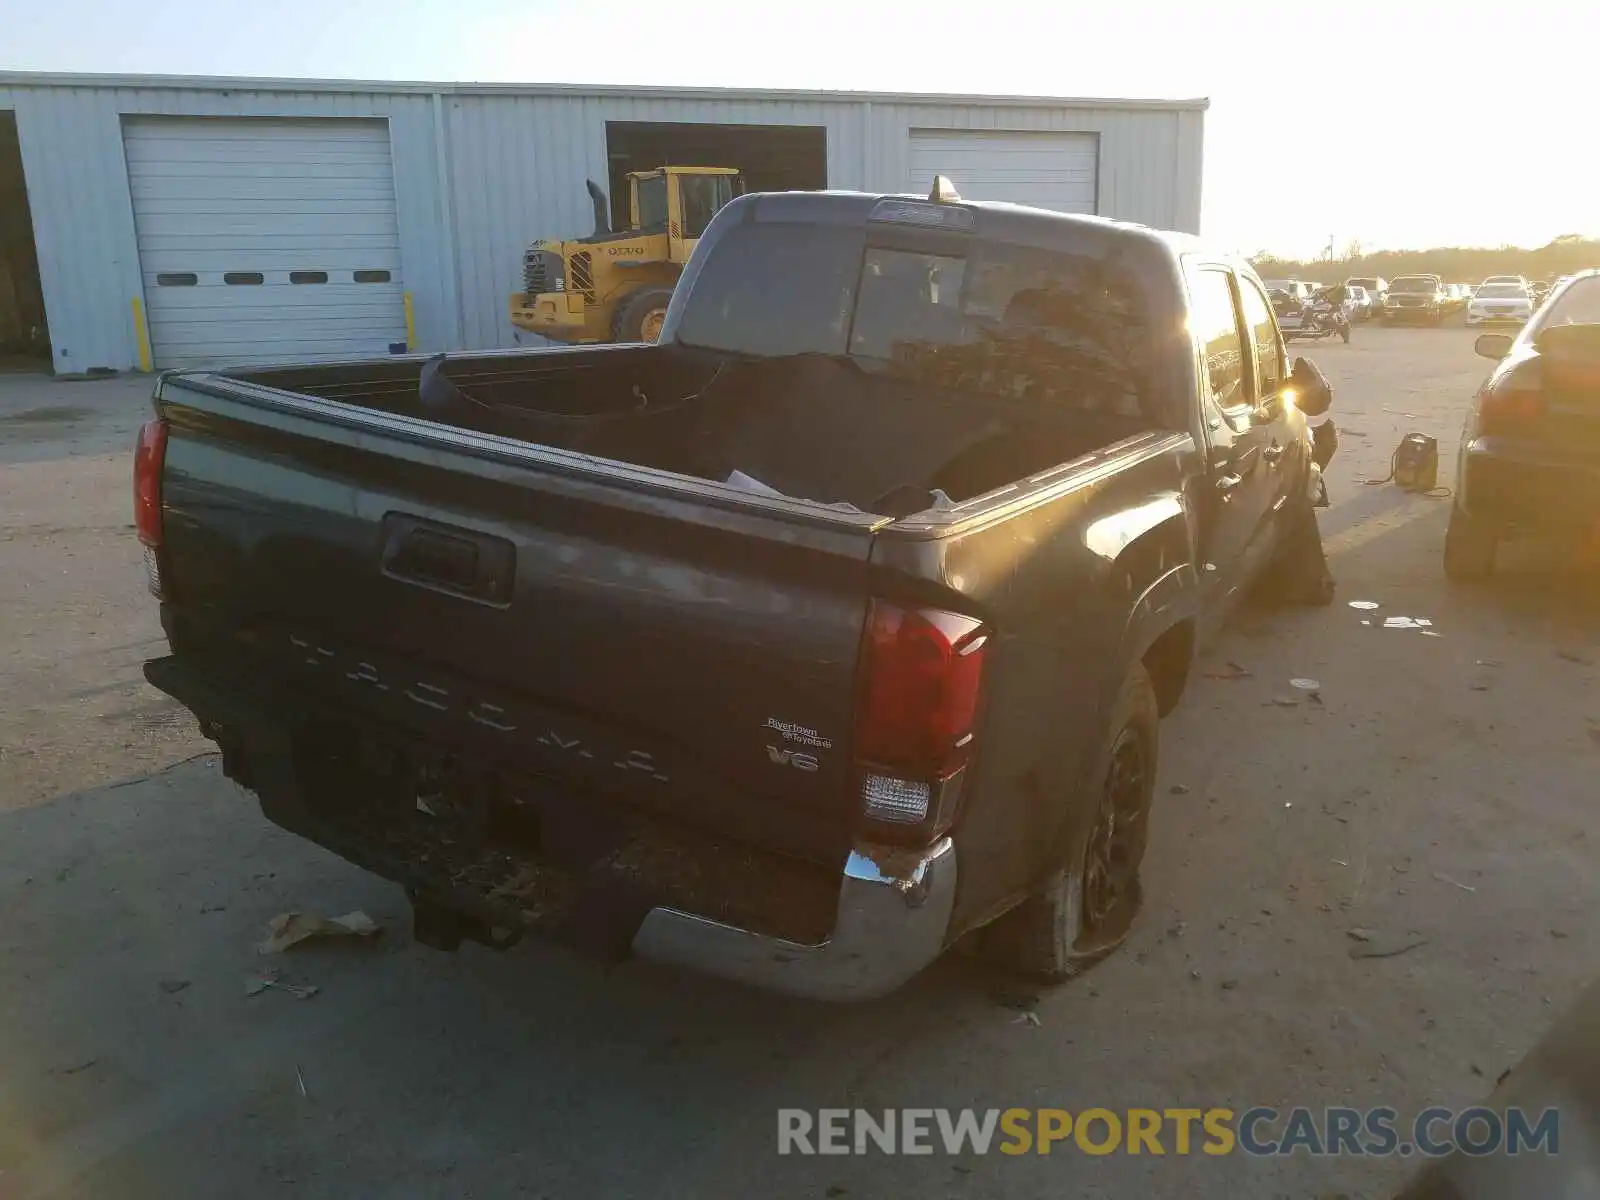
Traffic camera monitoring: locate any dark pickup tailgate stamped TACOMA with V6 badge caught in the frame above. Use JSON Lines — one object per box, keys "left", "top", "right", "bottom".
{"left": 158, "top": 376, "right": 883, "bottom": 862}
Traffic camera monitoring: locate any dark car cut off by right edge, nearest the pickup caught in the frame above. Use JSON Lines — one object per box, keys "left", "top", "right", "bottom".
{"left": 1445, "top": 270, "right": 1600, "bottom": 579}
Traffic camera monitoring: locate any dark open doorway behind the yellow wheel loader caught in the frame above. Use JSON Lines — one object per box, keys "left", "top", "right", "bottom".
{"left": 605, "top": 122, "right": 827, "bottom": 227}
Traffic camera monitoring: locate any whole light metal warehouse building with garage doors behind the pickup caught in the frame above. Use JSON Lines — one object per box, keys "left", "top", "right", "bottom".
{"left": 0, "top": 74, "right": 1206, "bottom": 373}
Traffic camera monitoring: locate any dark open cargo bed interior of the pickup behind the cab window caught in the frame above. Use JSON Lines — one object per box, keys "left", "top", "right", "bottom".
{"left": 232, "top": 346, "right": 1149, "bottom": 515}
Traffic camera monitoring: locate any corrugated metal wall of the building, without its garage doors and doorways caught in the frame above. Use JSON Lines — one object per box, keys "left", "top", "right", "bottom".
{"left": 0, "top": 82, "right": 1203, "bottom": 371}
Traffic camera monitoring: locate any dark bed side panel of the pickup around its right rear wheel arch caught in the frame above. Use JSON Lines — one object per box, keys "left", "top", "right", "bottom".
{"left": 874, "top": 432, "right": 1198, "bottom": 936}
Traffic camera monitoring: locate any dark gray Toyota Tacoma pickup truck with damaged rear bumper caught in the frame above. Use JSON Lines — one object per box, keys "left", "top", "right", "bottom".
{"left": 134, "top": 181, "right": 1331, "bottom": 998}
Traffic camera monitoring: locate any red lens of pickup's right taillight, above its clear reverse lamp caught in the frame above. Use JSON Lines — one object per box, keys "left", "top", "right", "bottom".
{"left": 856, "top": 600, "right": 989, "bottom": 782}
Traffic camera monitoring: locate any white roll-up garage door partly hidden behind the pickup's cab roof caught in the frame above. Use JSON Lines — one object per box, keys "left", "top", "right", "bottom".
{"left": 909, "top": 130, "right": 1099, "bottom": 213}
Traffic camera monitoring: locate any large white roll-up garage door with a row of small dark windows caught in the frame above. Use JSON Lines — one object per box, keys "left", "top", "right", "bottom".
{"left": 123, "top": 117, "right": 406, "bottom": 366}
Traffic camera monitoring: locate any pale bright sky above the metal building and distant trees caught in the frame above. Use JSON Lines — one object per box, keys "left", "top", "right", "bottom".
{"left": 0, "top": 0, "right": 1600, "bottom": 254}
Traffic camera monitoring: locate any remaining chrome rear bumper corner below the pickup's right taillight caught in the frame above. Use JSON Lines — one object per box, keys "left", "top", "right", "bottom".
{"left": 634, "top": 838, "right": 955, "bottom": 1000}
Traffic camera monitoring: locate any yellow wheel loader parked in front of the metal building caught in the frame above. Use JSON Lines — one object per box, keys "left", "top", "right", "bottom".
{"left": 510, "top": 166, "right": 744, "bottom": 342}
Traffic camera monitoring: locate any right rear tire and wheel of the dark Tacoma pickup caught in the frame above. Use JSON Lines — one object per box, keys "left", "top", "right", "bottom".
{"left": 981, "top": 662, "right": 1160, "bottom": 984}
